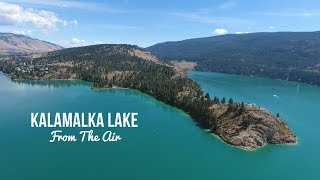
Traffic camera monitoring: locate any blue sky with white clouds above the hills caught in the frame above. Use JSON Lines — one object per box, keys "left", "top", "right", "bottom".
{"left": 0, "top": 0, "right": 320, "bottom": 47}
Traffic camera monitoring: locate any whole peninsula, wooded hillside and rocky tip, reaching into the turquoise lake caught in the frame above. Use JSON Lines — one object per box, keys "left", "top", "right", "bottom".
{"left": 0, "top": 44, "right": 296, "bottom": 150}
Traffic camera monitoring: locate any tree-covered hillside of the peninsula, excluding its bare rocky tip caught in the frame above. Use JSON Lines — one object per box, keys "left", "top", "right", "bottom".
{"left": 0, "top": 45, "right": 213, "bottom": 128}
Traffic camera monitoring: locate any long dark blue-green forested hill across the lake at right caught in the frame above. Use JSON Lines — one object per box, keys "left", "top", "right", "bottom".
{"left": 145, "top": 31, "right": 320, "bottom": 85}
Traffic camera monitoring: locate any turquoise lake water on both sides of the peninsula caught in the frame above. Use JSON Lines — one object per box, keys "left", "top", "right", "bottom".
{"left": 0, "top": 72, "right": 320, "bottom": 180}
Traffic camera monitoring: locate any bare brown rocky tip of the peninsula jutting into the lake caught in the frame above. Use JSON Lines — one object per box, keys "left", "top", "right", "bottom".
{"left": 214, "top": 104, "right": 296, "bottom": 150}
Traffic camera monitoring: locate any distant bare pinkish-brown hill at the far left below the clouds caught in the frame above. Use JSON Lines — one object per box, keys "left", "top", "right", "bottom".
{"left": 0, "top": 33, "right": 62, "bottom": 55}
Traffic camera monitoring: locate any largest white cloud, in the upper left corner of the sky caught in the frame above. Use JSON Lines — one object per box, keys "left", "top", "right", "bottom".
{"left": 0, "top": 2, "right": 65, "bottom": 32}
